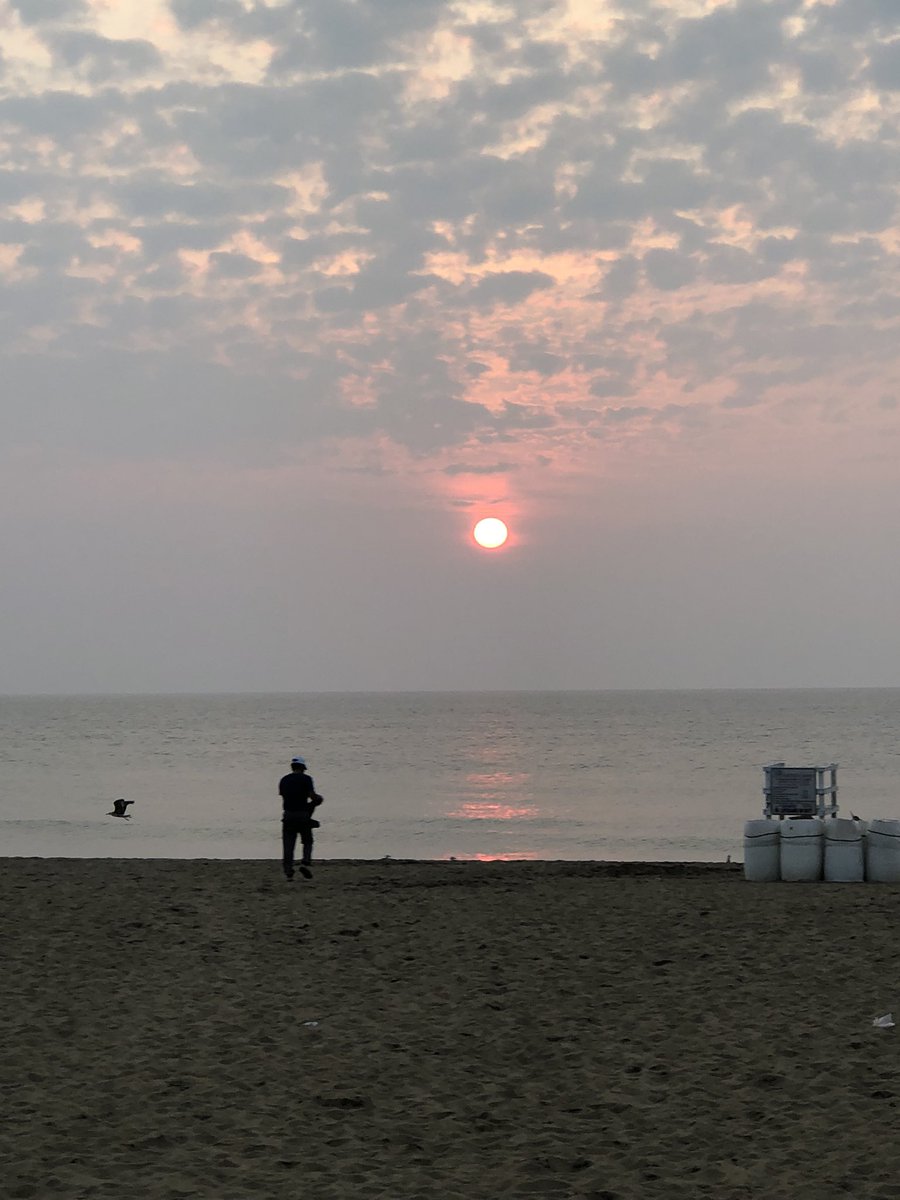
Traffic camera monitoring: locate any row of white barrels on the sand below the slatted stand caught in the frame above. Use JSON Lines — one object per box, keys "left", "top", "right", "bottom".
{"left": 744, "top": 817, "right": 900, "bottom": 883}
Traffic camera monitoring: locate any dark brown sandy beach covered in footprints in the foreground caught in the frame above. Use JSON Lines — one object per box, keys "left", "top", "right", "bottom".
{"left": 0, "top": 859, "right": 900, "bottom": 1200}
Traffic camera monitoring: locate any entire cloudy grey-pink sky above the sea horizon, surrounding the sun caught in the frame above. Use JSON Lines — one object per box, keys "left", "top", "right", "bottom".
{"left": 0, "top": 0, "right": 900, "bottom": 694}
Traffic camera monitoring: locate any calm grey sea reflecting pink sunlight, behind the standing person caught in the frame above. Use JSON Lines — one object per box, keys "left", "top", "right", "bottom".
{"left": 0, "top": 690, "right": 900, "bottom": 860}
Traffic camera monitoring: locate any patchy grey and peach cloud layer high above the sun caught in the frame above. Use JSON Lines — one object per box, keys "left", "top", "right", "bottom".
{"left": 0, "top": 0, "right": 900, "bottom": 482}
